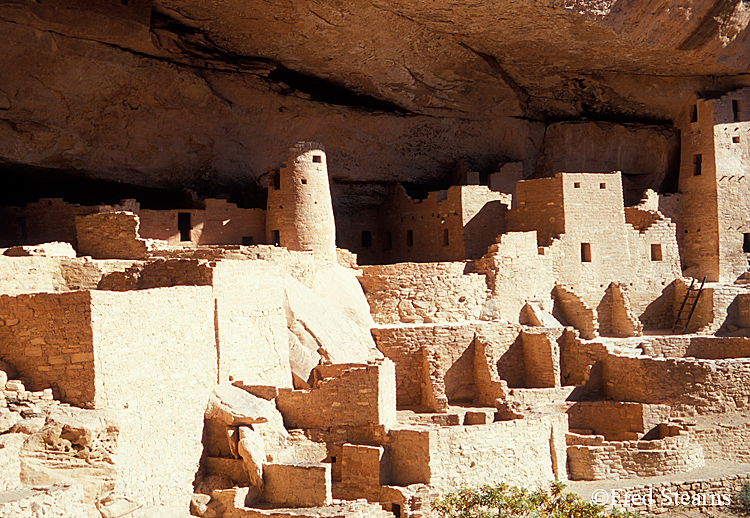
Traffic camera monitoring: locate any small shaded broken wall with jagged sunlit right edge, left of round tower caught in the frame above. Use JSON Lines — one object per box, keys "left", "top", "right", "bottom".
{"left": 75, "top": 212, "right": 148, "bottom": 259}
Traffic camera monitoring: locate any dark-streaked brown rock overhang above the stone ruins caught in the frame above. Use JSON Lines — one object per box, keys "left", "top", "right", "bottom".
{"left": 0, "top": 0, "right": 750, "bottom": 201}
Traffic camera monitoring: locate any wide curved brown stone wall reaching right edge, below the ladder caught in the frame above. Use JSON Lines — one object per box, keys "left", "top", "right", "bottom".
{"left": 603, "top": 354, "right": 750, "bottom": 414}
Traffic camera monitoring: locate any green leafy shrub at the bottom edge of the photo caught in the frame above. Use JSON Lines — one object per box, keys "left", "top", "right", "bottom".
{"left": 432, "top": 482, "right": 648, "bottom": 518}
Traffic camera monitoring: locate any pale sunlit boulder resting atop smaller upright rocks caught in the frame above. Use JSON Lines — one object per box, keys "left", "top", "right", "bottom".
{"left": 205, "top": 383, "right": 277, "bottom": 426}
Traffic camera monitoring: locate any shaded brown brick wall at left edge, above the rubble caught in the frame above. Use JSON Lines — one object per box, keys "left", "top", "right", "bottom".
{"left": 0, "top": 292, "right": 94, "bottom": 407}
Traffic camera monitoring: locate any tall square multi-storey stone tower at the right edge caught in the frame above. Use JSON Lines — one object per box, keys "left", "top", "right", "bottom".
{"left": 675, "top": 88, "right": 750, "bottom": 282}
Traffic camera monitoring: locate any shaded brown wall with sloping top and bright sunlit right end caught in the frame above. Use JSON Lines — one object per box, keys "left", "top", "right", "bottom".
{"left": 276, "top": 359, "right": 396, "bottom": 429}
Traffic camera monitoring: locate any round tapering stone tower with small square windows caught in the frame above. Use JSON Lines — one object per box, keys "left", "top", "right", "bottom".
{"left": 266, "top": 142, "right": 336, "bottom": 262}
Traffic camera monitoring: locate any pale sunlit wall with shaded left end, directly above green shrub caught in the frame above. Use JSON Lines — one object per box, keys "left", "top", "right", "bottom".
{"left": 390, "top": 414, "right": 567, "bottom": 491}
